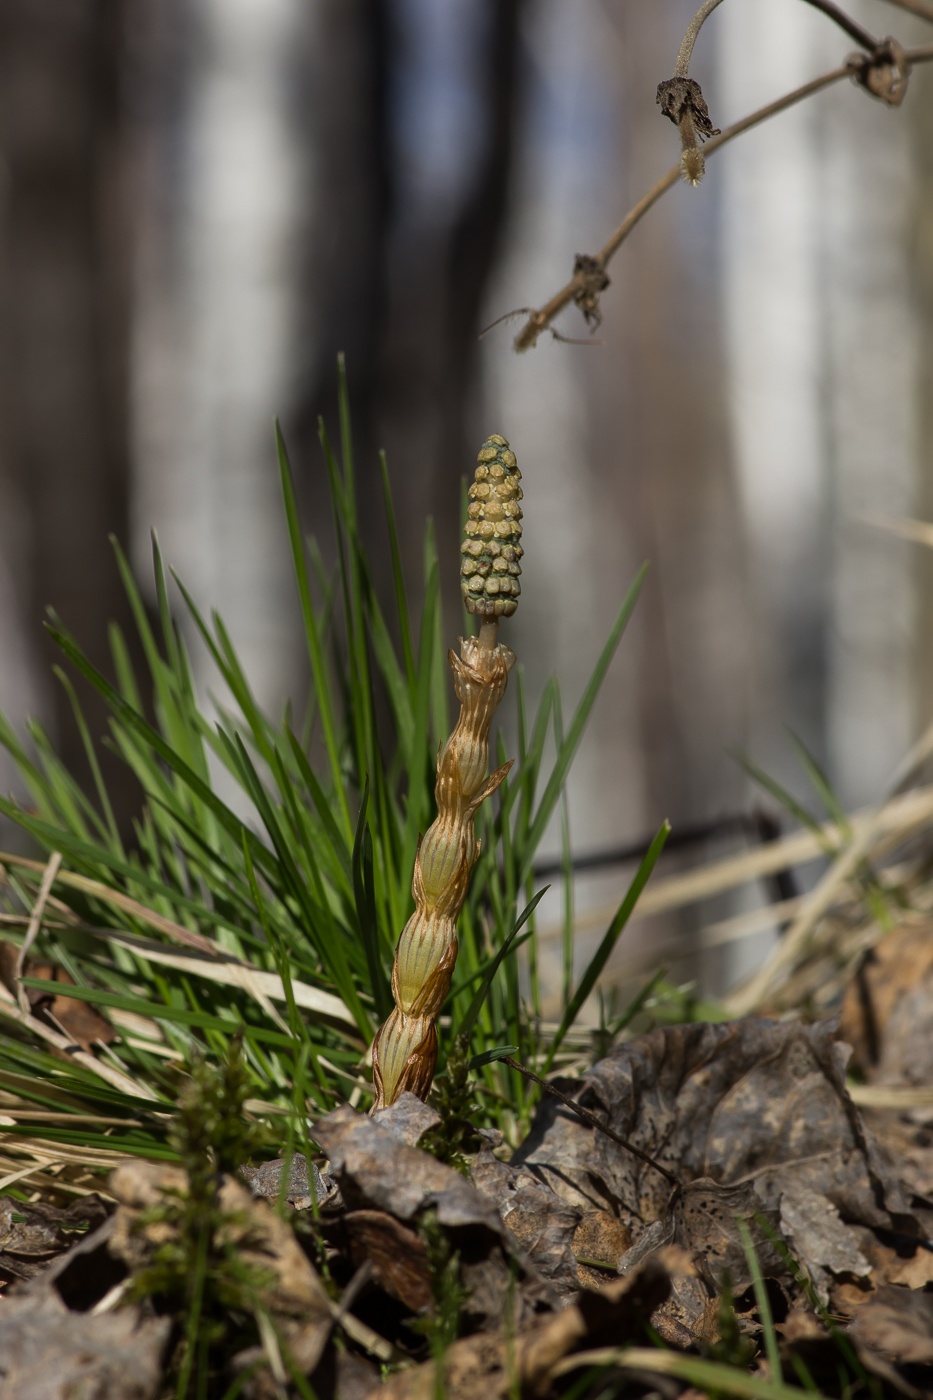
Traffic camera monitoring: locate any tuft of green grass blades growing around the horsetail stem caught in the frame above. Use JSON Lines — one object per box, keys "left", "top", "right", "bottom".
{"left": 0, "top": 370, "right": 652, "bottom": 1180}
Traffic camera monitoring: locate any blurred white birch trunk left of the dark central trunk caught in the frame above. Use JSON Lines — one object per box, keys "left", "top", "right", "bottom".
{"left": 134, "top": 0, "right": 308, "bottom": 708}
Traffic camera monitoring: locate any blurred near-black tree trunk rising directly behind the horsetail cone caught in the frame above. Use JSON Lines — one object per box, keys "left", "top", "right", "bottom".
{"left": 293, "top": 0, "right": 524, "bottom": 635}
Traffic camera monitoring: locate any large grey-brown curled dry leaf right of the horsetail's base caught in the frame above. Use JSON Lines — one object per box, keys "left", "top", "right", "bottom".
{"left": 510, "top": 1018, "right": 920, "bottom": 1287}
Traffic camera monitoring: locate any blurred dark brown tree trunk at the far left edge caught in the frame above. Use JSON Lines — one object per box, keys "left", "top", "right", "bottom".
{"left": 0, "top": 0, "right": 132, "bottom": 813}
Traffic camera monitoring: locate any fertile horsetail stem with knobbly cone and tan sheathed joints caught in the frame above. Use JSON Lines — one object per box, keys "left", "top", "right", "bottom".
{"left": 373, "top": 434, "right": 523, "bottom": 1109}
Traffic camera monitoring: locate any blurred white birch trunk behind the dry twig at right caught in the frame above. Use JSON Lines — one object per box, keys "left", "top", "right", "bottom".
{"left": 710, "top": 0, "right": 922, "bottom": 805}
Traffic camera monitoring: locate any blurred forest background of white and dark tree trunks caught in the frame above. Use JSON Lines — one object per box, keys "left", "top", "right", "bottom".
{"left": 0, "top": 0, "right": 933, "bottom": 1008}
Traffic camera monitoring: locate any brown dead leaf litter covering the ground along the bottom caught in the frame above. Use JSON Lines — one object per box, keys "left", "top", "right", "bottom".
{"left": 0, "top": 996, "right": 933, "bottom": 1400}
